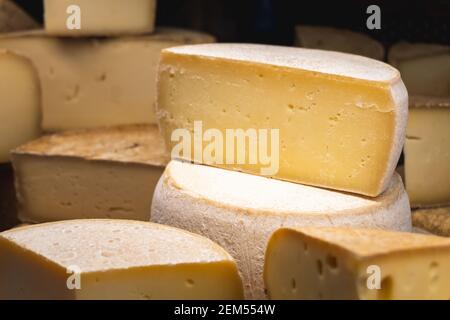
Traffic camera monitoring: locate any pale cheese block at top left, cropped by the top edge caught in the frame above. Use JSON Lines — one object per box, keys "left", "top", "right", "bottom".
{"left": 44, "top": 0, "right": 156, "bottom": 36}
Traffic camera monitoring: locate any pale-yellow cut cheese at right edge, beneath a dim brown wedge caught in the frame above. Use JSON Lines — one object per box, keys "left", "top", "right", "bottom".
{"left": 405, "top": 97, "right": 450, "bottom": 207}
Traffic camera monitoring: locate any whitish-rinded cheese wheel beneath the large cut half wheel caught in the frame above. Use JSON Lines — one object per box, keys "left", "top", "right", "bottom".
{"left": 151, "top": 161, "right": 411, "bottom": 299}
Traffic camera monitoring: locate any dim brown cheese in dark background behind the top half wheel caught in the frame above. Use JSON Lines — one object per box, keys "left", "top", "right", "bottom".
{"left": 295, "top": 26, "right": 385, "bottom": 60}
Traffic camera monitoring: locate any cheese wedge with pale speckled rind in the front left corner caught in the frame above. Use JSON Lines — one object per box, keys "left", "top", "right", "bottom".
{"left": 0, "top": 220, "right": 243, "bottom": 300}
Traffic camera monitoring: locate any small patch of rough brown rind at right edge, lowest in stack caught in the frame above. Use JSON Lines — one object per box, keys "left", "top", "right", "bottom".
{"left": 412, "top": 207, "right": 450, "bottom": 237}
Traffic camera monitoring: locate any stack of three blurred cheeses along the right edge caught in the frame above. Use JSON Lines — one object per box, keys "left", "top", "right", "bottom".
{"left": 389, "top": 42, "right": 450, "bottom": 235}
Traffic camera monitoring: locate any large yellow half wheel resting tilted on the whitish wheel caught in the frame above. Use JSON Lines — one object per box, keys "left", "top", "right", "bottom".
{"left": 157, "top": 44, "right": 408, "bottom": 196}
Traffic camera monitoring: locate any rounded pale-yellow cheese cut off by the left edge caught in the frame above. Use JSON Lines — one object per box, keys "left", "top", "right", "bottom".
{"left": 0, "top": 49, "right": 41, "bottom": 163}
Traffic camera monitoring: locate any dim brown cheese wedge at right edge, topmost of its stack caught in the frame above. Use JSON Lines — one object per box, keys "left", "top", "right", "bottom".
{"left": 388, "top": 42, "right": 450, "bottom": 97}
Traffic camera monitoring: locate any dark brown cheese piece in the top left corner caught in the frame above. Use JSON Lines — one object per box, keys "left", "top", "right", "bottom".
{"left": 0, "top": 0, "right": 39, "bottom": 32}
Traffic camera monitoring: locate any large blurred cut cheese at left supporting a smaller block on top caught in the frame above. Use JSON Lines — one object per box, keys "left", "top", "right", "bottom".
{"left": 0, "top": 29, "right": 214, "bottom": 131}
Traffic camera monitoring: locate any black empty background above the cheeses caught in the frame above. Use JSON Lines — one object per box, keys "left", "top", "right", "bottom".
{"left": 12, "top": 0, "right": 450, "bottom": 46}
